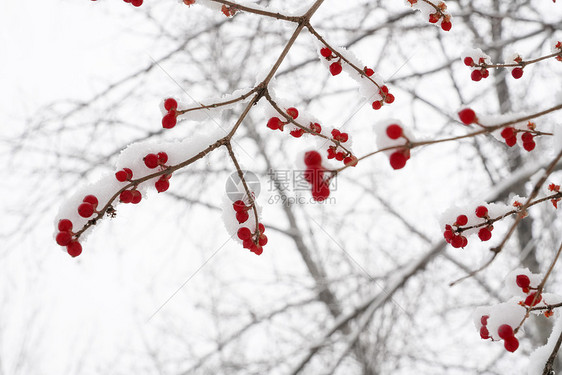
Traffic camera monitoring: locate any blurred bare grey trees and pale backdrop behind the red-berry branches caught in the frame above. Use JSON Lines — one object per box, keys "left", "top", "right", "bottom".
{"left": 0, "top": 0, "right": 562, "bottom": 375}
